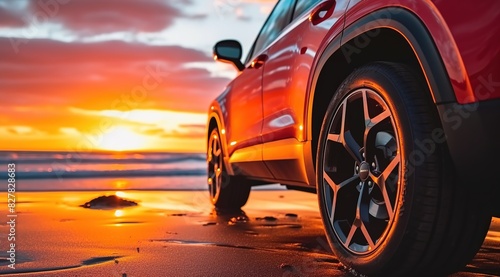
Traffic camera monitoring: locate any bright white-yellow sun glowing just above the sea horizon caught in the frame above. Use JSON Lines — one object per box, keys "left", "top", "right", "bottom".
{"left": 99, "top": 126, "right": 148, "bottom": 151}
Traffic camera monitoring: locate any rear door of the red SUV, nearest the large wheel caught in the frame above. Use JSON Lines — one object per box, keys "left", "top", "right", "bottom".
{"left": 262, "top": 0, "right": 348, "bottom": 182}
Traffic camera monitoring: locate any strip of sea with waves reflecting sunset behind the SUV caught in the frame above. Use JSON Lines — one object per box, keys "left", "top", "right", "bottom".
{"left": 0, "top": 151, "right": 284, "bottom": 191}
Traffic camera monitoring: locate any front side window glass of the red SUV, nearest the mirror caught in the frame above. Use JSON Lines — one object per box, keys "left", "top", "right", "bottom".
{"left": 251, "top": 0, "right": 295, "bottom": 58}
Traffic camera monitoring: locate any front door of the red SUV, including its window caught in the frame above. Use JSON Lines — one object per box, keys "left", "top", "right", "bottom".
{"left": 225, "top": 0, "right": 295, "bottom": 178}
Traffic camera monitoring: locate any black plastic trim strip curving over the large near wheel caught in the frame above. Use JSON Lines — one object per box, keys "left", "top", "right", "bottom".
{"left": 306, "top": 4, "right": 466, "bottom": 140}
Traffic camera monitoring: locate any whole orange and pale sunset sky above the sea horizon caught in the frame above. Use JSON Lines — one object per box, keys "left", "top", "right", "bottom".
{"left": 0, "top": 0, "right": 276, "bottom": 152}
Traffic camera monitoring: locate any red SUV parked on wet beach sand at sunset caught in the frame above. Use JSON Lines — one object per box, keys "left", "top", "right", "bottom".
{"left": 207, "top": 0, "right": 500, "bottom": 276}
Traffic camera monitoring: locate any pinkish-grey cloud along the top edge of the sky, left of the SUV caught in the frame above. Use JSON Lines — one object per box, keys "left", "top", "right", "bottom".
{"left": 29, "top": 0, "right": 183, "bottom": 35}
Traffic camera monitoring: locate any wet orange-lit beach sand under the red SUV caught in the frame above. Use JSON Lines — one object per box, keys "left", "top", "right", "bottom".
{"left": 0, "top": 191, "right": 500, "bottom": 277}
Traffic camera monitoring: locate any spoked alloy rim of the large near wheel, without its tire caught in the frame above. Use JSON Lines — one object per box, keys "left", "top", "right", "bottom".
{"left": 320, "top": 88, "right": 401, "bottom": 254}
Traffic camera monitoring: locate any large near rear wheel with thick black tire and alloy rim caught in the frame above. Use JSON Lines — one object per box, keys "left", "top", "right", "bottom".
{"left": 316, "top": 62, "right": 491, "bottom": 276}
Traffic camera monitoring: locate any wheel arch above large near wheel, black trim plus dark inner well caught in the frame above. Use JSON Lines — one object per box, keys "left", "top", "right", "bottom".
{"left": 307, "top": 7, "right": 456, "bottom": 167}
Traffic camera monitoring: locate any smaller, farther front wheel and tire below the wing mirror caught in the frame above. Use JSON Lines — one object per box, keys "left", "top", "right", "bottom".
{"left": 207, "top": 128, "right": 251, "bottom": 210}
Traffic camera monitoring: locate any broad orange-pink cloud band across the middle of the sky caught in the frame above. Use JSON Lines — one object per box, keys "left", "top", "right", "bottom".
{"left": 0, "top": 38, "right": 228, "bottom": 115}
